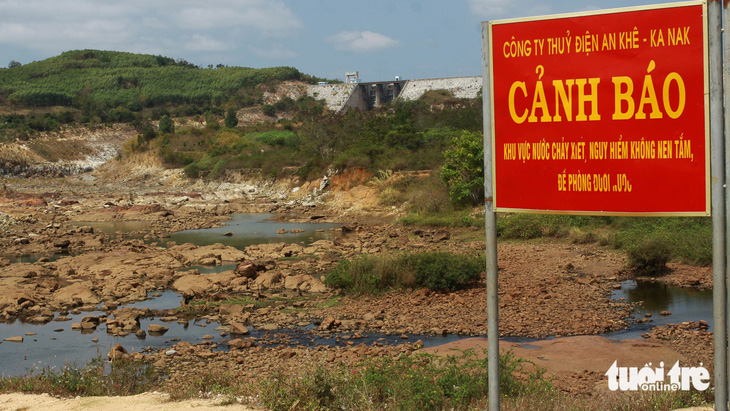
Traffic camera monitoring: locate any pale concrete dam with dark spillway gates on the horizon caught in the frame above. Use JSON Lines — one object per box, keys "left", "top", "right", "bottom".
{"left": 307, "top": 76, "right": 482, "bottom": 111}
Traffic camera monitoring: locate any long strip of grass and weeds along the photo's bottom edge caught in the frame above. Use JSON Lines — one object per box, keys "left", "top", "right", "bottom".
{"left": 0, "top": 351, "right": 712, "bottom": 411}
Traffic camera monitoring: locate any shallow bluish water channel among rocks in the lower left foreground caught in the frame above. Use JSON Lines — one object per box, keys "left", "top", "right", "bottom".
{"left": 0, "top": 291, "right": 465, "bottom": 376}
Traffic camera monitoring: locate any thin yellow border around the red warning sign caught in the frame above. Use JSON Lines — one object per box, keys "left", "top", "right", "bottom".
{"left": 489, "top": 0, "right": 712, "bottom": 217}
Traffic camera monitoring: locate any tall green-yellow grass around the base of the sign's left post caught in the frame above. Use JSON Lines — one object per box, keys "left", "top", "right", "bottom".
{"left": 260, "top": 351, "right": 553, "bottom": 410}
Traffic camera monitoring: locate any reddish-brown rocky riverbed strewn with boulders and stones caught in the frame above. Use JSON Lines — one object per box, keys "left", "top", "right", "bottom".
{"left": 0, "top": 176, "right": 711, "bottom": 400}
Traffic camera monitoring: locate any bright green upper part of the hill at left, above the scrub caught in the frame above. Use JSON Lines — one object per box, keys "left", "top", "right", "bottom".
{"left": 0, "top": 50, "right": 314, "bottom": 111}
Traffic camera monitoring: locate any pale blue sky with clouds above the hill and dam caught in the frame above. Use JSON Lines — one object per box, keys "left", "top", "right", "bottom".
{"left": 0, "top": 0, "right": 688, "bottom": 81}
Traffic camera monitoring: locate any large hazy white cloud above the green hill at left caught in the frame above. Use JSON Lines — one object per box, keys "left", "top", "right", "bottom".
{"left": 0, "top": 0, "right": 304, "bottom": 58}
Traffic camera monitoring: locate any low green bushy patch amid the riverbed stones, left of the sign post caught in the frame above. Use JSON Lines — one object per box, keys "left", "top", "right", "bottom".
{"left": 324, "top": 252, "right": 485, "bottom": 294}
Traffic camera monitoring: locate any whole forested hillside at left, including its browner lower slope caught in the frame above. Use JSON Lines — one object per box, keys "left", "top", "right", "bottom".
{"left": 0, "top": 50, "right": 330, "bottom": 141}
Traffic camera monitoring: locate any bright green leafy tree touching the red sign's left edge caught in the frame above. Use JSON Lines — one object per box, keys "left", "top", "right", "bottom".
{"left": 441, "top": 131, "right": 484, "bottom": 205}
